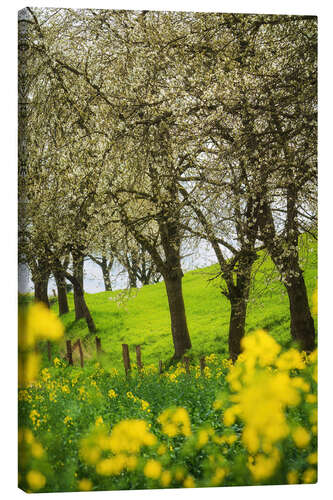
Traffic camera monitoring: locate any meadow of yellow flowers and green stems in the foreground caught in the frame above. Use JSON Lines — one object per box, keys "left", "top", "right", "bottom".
{"left": 18, "top": 304, "right": 317, "bottom": 492}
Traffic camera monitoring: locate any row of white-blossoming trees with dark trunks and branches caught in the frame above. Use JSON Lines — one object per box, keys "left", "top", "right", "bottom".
{"left": 19, "top": 8, "right": 317, "bottom": 359}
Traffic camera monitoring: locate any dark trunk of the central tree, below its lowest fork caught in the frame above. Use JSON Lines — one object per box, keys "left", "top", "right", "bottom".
{"left": 164, "top": 276, "right": 192, "bottom": 359}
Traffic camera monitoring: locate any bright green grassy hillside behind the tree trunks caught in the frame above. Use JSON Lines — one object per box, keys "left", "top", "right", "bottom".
{"left": 53, "top": 237, "right": 317, "bottom": 368}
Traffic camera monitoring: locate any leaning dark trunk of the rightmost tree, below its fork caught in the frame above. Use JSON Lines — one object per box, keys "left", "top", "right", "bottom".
{"left": 285, "top": 271, "right": 315, "bottom": 352}
